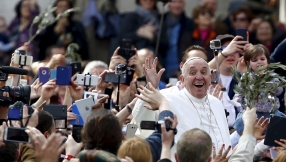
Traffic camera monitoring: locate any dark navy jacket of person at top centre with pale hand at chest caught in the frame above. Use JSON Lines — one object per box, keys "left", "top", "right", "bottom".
{"left": 118, "top": 12, "right": 159, "bottom": 50}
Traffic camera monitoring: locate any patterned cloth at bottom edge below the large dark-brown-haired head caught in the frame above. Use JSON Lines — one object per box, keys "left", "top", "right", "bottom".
{"left": 78, "top": 150, "right": 121, "bottom": 162}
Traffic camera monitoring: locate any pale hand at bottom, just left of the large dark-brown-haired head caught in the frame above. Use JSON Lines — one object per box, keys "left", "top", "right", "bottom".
{"left": 65, "top": 135, "right": 83, "bottom": 156}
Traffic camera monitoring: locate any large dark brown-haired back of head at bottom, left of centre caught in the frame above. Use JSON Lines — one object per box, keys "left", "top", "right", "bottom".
{"left": 82, "top": 109, "right": 122, "bottom": 154}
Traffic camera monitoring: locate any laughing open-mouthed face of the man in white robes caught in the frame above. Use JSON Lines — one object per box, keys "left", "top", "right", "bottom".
{"left": 181, "top": 59, "right": 212, "bottom": 99}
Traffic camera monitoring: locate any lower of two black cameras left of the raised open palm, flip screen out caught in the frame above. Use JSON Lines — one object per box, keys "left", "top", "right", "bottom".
{"left": 104, "top": 64, "right": 135, "bottom": 86}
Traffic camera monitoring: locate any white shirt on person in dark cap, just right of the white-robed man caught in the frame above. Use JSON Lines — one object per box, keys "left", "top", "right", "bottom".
{"left": 220, "top": 74, "right": 236, "bottom": 127}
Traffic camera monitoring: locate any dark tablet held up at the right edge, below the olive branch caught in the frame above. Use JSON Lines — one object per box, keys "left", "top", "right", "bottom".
{"left": 264, "top": 115, "right": 286, "bottom": 146}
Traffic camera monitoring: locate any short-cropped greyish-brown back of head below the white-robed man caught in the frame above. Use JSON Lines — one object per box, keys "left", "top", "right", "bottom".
{"left": 176, "top": 128, "right": 212, "bottom": 162}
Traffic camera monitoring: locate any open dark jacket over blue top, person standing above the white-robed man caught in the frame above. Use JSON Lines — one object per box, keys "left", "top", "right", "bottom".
{"left": 159, "top": 13, "right": 194, "bottom": 60}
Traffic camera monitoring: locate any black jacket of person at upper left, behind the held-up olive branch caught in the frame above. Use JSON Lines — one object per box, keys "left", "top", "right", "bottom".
{"left": 38, "top": 20, "right": 89, "bottom": 60}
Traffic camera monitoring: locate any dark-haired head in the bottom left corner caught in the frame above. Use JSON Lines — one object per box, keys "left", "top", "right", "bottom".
{"left": 0, "top": 141, "right": 19, "bottom": 162}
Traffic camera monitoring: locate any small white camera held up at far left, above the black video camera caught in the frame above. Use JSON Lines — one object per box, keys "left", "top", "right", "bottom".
{"left": 14, "top": 50, "right": 33, "bottom": 66}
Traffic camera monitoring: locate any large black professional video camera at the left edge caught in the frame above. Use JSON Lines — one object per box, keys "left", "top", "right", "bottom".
{"left": 0, "top": 85, "right": 31, "bottom": 105}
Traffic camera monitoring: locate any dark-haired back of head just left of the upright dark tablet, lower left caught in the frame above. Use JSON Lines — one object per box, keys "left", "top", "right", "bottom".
{"left": 36, "top": 110, "right": 54, "bottom": 134}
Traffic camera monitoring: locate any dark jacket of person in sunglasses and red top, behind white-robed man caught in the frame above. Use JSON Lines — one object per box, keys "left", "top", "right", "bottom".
{"left": 180, "top": 28, "right": 216, "bottom": 61}
